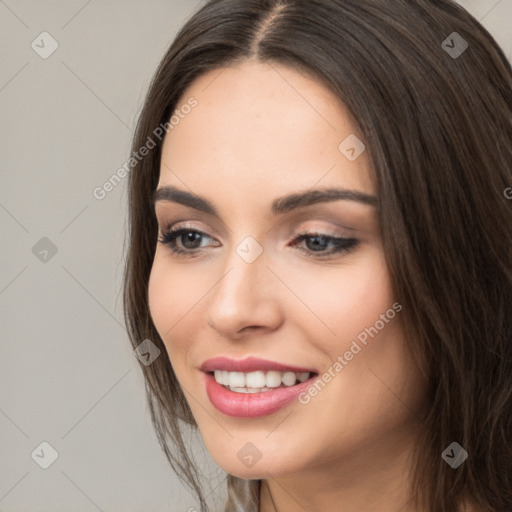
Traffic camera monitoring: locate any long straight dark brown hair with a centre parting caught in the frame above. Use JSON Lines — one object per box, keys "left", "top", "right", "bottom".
{"left": 123, "top": 0, "right": 512, "bottom": 512}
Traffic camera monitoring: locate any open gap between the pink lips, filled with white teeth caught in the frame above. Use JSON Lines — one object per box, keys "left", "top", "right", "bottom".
{"left": 208, "top": 370, "right": 317, "bottom": 393}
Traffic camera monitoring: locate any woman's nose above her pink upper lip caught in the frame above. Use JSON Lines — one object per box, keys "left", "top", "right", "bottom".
{"left": 207, "top": 242, "right": 283, "bottom": 339}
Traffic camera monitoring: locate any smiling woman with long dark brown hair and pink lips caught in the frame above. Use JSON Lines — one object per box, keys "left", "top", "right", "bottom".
{"left": 124, "top": 0, "right": 512, "bottom": 512}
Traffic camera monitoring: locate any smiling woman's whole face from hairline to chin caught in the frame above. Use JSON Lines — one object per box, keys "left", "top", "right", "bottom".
{"left": 149, "top": 61, "right": 424, "bottom": 479}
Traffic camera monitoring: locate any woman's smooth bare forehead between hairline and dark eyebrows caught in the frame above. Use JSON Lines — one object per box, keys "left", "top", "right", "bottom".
{"left": 159, "top": 61, "right": 375, "bottom": 206}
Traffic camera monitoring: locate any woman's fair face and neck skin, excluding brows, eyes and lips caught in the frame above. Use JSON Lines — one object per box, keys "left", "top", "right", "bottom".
{"left": 148, "top": 61, "right": 432, "bottom": 512}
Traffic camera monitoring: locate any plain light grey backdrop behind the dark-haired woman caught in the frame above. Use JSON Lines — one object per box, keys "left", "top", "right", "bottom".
{"left": 0, "top": 0, "right": 512, "bottom": 512}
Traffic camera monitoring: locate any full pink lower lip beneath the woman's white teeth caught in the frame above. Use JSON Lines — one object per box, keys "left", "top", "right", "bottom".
{"left": 204, "top": 373, "right": 318, "bottom": 418}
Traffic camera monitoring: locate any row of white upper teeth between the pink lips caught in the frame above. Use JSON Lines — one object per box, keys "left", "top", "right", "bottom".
{"left": 214, "top": 370, "right": 309, "bottom": 391}
